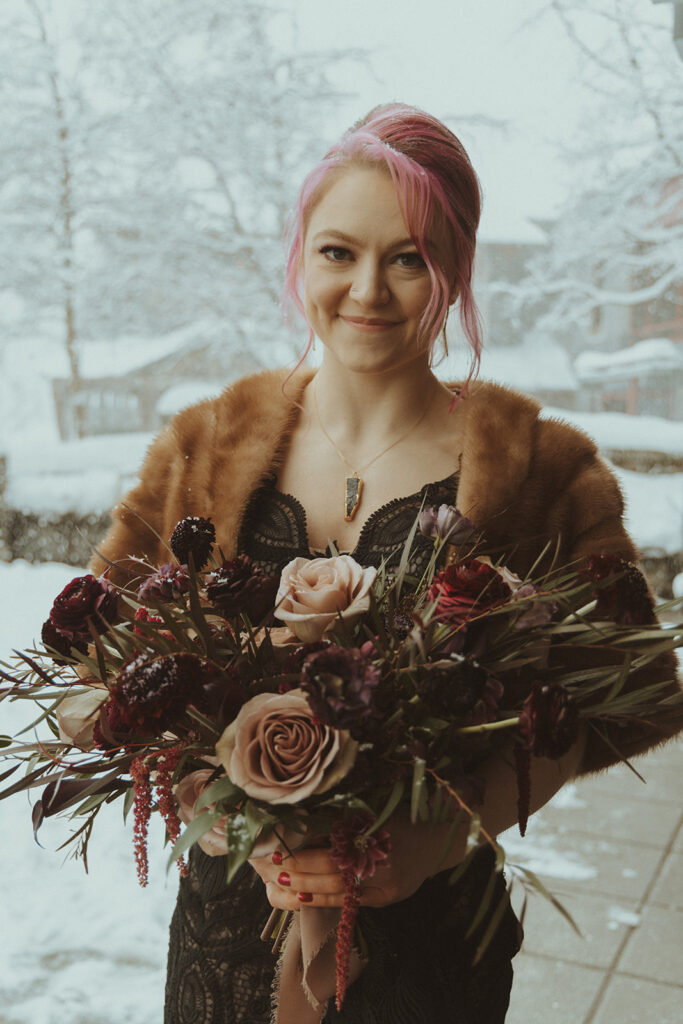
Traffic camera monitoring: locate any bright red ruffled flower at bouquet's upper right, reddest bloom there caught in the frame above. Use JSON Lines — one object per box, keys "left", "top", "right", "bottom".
{"left": 427, "top": 558, "right": 512, "bottom": 627}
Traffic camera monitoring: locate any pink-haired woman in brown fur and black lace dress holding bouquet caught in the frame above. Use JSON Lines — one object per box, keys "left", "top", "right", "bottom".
{"left": 95, "top": 104, "right": 673, "bottom": 1024}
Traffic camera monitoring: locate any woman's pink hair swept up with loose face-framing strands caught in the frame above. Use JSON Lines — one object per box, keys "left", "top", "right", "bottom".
{"left": 283, "top": 103, "right": 482, "bottom": 381}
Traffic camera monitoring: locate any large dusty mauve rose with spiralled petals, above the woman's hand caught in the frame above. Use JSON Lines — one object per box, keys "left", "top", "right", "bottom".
{"left": 216, "top": 690, "right": 358, "bottom": 804}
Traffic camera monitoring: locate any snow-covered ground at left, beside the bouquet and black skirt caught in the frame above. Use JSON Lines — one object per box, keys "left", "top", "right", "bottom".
{"left": 0, "top": 561, "right": 176, "bottom": 1024}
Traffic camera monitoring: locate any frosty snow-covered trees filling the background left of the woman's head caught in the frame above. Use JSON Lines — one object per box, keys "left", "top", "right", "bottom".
{"left": 0, "top": 0, "right": 357, "bottom": 403}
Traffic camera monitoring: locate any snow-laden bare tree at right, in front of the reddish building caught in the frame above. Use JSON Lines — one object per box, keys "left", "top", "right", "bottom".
{"left": 508, "top": 0, "right": 683, "bottom": 351}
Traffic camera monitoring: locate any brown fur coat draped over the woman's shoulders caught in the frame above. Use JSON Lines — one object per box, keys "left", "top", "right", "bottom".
{"left": 93, "top": 371, "right": 676, "bottom": 771}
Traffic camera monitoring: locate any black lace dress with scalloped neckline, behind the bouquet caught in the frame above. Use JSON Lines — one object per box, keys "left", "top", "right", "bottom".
{"left": 164, "top": 474, "right": 520, "bottom": 1024}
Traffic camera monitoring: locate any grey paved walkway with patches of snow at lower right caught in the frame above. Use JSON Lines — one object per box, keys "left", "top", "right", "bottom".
{"left": 504, "top": 741, "right": 683, "bottom": 1024}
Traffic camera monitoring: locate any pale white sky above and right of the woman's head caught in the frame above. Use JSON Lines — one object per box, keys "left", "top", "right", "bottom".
{"left": 282, "top": 0, "right": 672, "bottom": 240}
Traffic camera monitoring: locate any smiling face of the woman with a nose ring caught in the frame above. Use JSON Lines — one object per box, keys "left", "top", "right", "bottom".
{"left": 303, "top": 166, "right": 438, "bottom": 373}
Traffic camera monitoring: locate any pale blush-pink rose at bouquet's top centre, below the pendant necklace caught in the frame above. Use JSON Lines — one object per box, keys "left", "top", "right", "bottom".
{"left": 275, "top": 555, "right": 377, "bottom": 643}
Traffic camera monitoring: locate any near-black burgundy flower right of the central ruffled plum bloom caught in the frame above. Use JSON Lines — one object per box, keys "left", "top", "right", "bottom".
{"left": 418, "top": 659, "right": 504, "bottom": 725}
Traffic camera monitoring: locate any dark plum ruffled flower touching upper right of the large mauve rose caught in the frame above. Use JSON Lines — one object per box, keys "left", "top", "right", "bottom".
{"left": 301, "top": 644, "right": 381, "bottom": 735}
